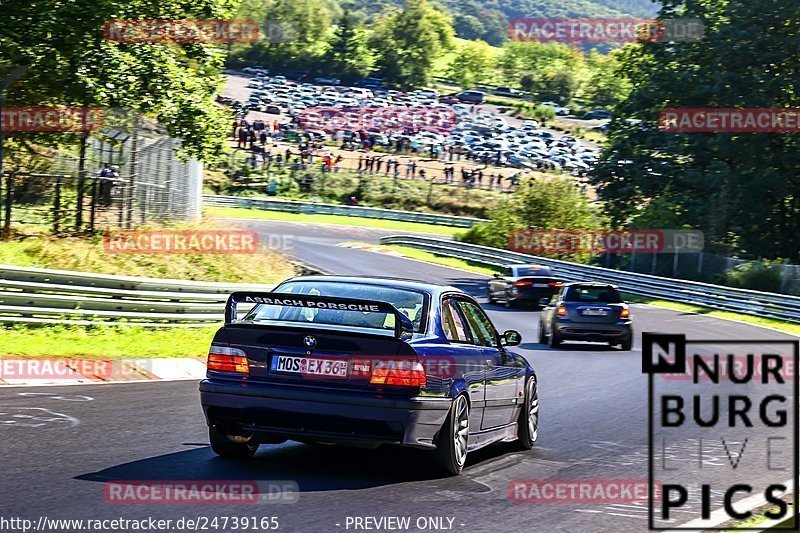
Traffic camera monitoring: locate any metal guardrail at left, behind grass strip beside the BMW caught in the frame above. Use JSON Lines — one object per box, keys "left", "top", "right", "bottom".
{"left": 0, "top": 265, "right": 273, "bottom": 327}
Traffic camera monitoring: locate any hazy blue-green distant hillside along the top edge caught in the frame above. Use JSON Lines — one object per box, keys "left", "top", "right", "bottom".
{"left": 339, "top": 0, "right": 659, "bottom": 46}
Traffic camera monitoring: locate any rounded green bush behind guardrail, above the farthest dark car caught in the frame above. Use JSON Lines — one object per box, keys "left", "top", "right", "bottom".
{"left": 461, "top": 178, "right": 602, "bottom": 256}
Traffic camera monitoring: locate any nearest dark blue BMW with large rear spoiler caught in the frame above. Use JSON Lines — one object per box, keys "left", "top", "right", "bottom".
{"left": 200, "top": 276, "right": 539, "bottom": 474}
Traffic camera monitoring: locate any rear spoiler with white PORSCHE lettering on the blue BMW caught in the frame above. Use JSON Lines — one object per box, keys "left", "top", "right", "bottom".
{"left": 225, "top": 292, "right": 414, "bottom": 340}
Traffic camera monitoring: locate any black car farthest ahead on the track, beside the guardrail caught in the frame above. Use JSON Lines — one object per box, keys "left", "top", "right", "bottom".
{"left": 486, "top": 265, "right": 562, "bottom": 307}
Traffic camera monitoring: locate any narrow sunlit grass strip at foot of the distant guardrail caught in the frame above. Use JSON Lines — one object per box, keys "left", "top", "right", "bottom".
{"left": 204, "top": 207, "right": 465, "bottom": 235}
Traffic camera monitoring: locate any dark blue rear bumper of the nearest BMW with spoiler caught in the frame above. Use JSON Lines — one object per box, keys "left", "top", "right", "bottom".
{"left": 200, "top": 380, "right": 452, "bottom": 448}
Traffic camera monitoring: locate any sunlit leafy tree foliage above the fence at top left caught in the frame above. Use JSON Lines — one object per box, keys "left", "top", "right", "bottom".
{"left": 0, "top": 0, "right": 232, "bottom": 158}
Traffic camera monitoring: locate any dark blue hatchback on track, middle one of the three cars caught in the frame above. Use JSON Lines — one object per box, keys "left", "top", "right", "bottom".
{"left": 539, "top": 283, "right": 633, "bottom": 350}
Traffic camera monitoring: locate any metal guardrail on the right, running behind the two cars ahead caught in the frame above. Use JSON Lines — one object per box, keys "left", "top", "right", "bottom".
{"left": 381, "top": 235, "right": 800, "bottom": 322}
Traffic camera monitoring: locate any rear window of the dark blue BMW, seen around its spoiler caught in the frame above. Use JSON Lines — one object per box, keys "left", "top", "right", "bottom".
{"left": 244, "top": 281, "right": 427, "bottom": 333}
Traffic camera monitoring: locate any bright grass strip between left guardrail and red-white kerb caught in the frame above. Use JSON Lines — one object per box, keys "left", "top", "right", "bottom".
{"left": 0, "top": 325, "right": 217, "bottom": 359}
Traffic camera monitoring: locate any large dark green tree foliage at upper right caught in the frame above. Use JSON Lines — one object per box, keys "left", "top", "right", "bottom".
{"left": 594, "top": 0, "right": 800, "bottom": 262}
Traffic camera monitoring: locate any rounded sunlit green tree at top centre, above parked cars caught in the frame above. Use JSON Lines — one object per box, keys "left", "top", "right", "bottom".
{"left": 370, "top": 0, "right": 453, "bottom": 87}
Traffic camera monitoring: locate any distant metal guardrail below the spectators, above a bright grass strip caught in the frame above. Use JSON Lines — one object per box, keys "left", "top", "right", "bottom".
{"left": 203, "top": 195, "right": 483, "bottom": 228}
